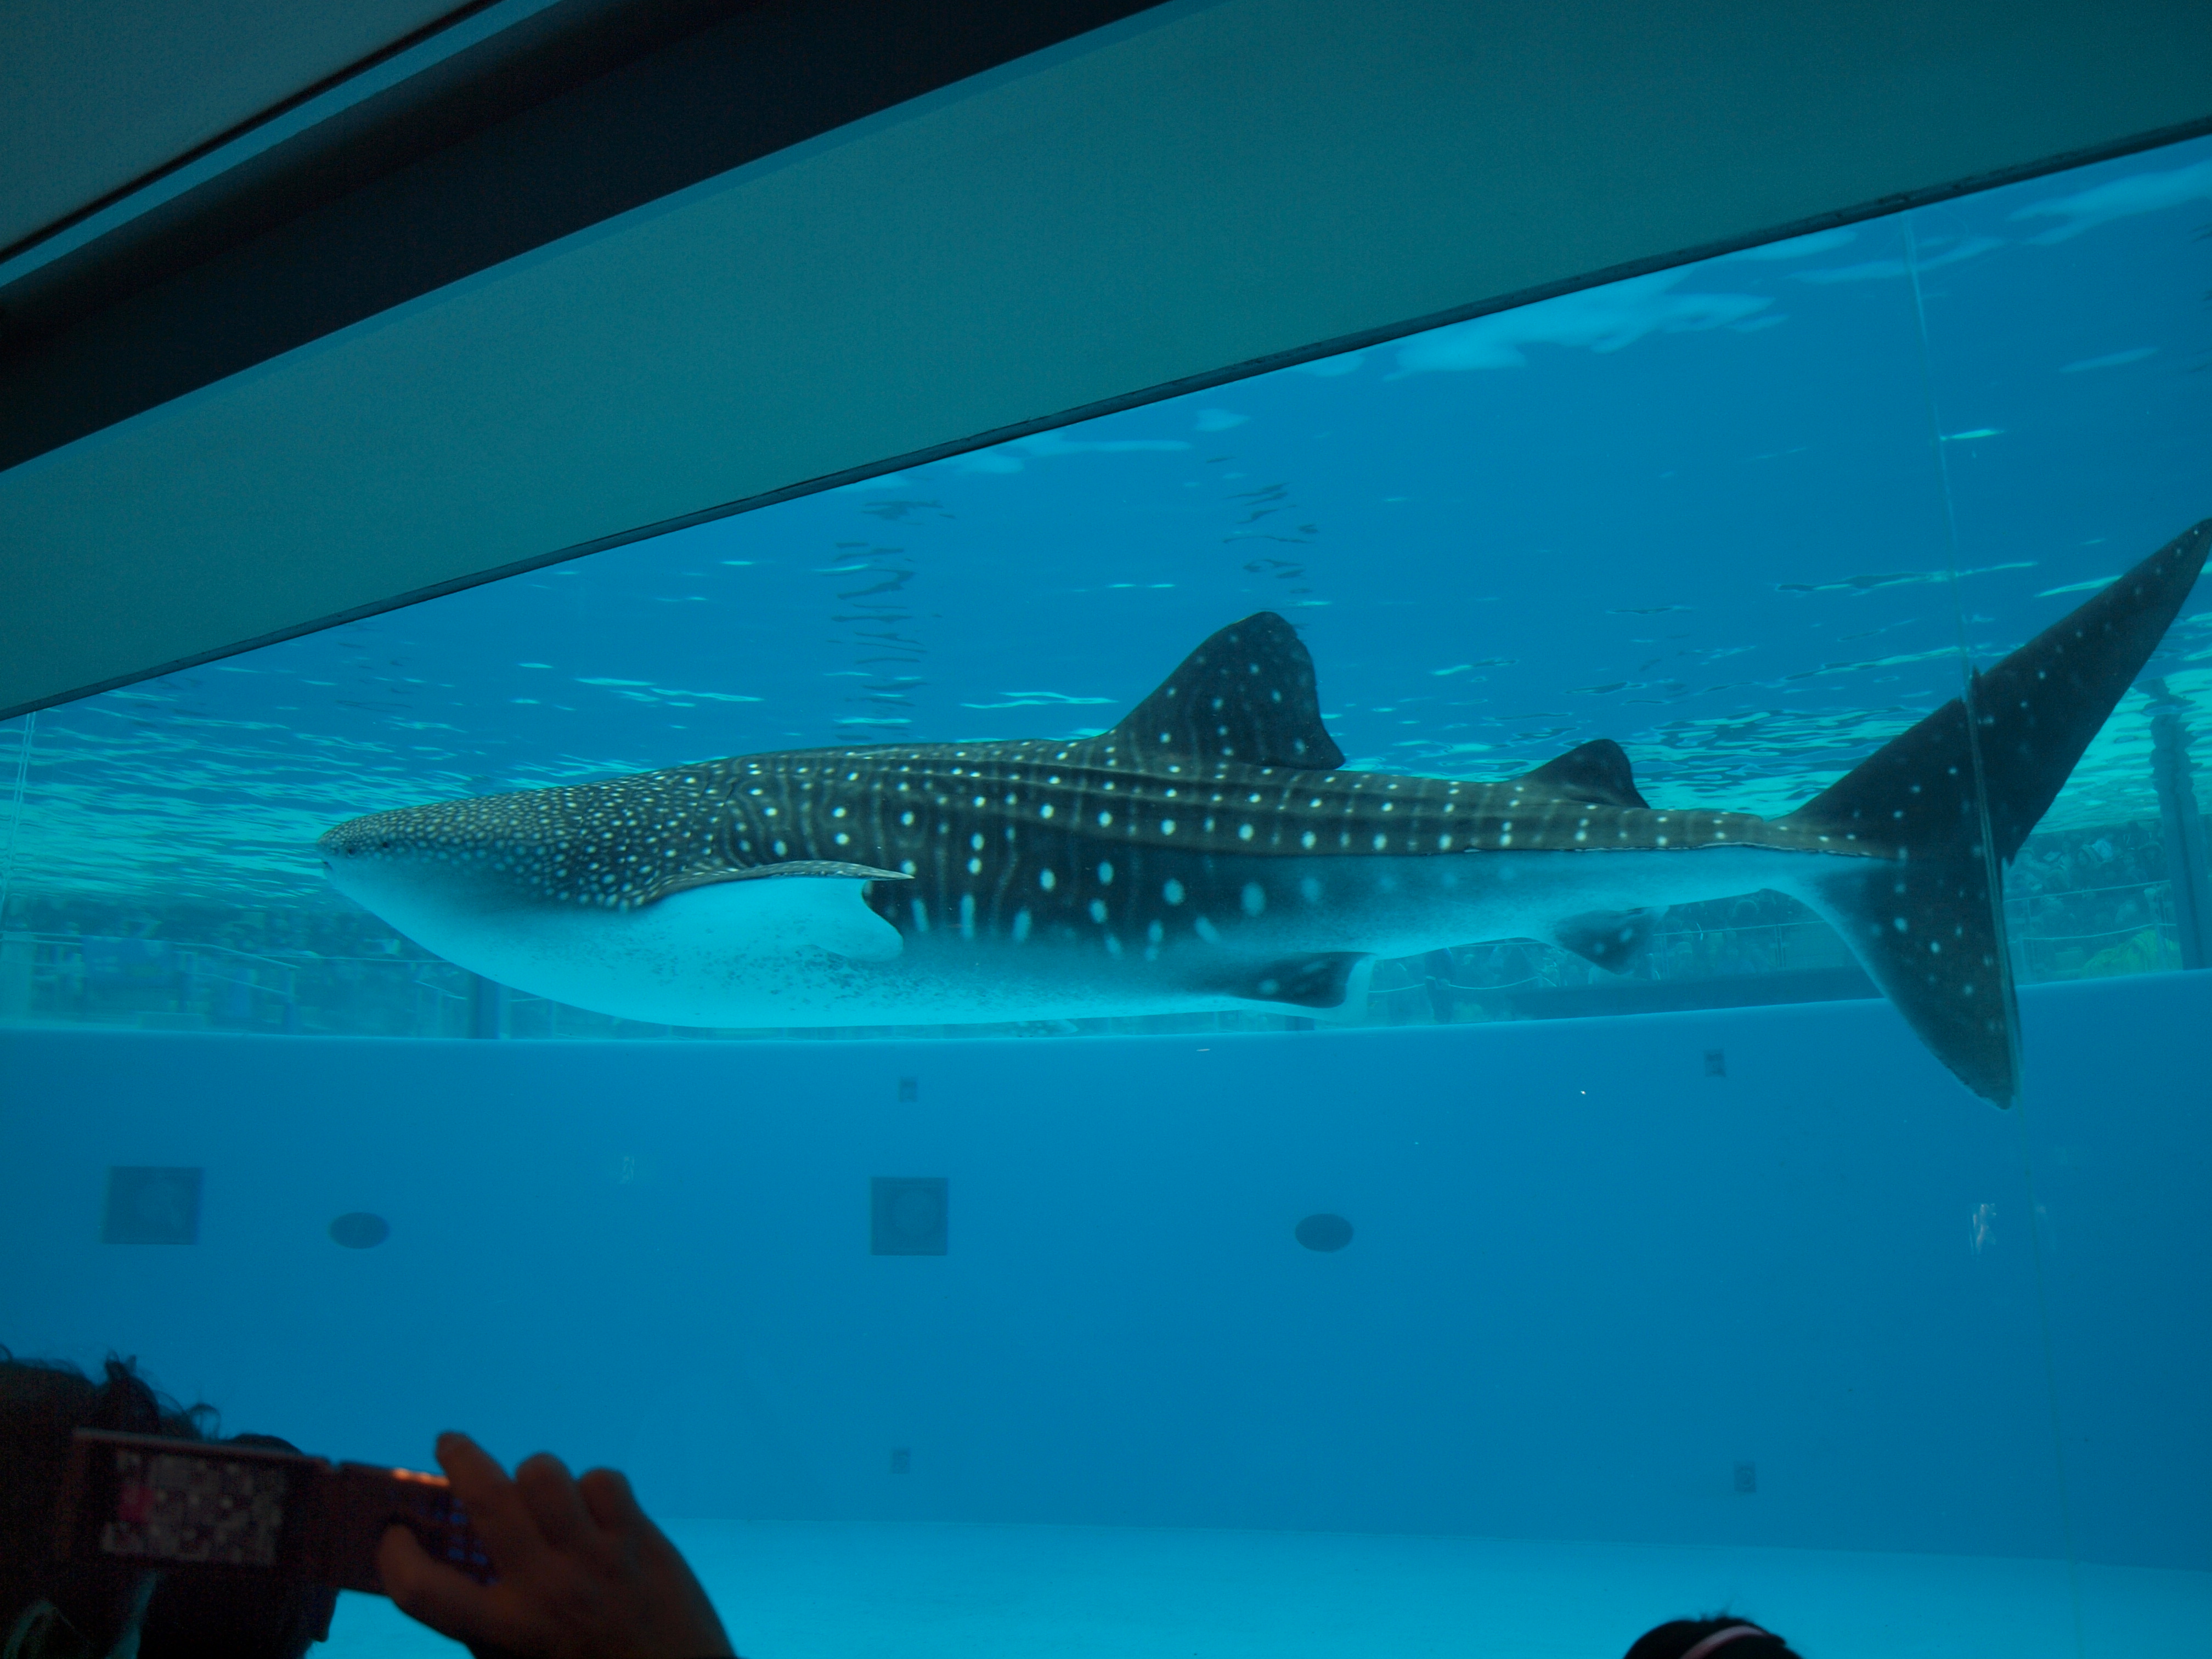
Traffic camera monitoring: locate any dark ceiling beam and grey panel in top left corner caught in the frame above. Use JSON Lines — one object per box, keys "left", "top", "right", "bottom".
{"left": 0, "top": 0, "right": 1150, "bottom": 469}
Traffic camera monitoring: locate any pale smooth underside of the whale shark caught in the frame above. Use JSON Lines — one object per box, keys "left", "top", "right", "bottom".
{"left": 358, "top": 847, "right": 1814, "bottom": 1029}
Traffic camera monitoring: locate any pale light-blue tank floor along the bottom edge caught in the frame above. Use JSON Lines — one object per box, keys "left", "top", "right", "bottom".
{"left": 321, "top": 1520, "right": 2212, "bottom": 1659}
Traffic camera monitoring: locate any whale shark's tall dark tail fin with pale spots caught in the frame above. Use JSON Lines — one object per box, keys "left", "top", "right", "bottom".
{"left": 1783, "top": 520, "right": 2212, "bottom": 1106}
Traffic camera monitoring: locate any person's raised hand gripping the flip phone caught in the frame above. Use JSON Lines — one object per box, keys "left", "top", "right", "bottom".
{"left": 376, "top": 1434, "right": 735, "bottom": 1659}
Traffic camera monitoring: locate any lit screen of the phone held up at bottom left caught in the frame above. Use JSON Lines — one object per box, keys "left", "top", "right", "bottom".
{"left": 99, "top": 1447, "right": 290, "bottom": 1566}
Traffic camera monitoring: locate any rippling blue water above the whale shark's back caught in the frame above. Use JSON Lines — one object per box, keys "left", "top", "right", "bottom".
{"left": 0, "top": 142, "right": 2212, "bottom": 905}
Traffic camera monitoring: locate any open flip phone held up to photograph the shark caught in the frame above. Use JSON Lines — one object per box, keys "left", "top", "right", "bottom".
{"left": 55, "top": 1429, "right": 495, "bottom": 1595}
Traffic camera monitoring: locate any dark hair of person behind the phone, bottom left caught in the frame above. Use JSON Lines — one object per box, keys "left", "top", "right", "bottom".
{"left": 0, "top": 1347, "right": 215, "bottom": 1652}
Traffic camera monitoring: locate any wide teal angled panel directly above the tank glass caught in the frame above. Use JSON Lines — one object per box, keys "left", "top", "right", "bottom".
{"left": 0, "top": 0, "right": 2212, "bottom": 710}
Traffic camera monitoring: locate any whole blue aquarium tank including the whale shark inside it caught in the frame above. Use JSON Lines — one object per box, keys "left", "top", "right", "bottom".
{"left": 0, "top": 139, "right": 2212, "bottom": 1659}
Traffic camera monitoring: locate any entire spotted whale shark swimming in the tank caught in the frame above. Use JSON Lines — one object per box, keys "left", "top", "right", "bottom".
{"left": 319, "top": 520, "right": 2212, "bottom": 1104}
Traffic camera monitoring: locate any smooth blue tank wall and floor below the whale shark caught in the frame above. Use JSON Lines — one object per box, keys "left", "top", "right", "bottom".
{"left": 0, "top": 973, "right": 2212, "bottom": 1659}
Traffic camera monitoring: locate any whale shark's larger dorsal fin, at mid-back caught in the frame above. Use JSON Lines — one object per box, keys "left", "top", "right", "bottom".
{"left": 1095, "top": 611, "right": 1345, "bottom": 772}
